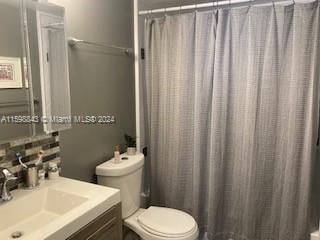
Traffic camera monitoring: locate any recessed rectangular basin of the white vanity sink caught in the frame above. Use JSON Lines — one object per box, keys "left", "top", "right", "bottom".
{"left": 0, "top": 188, "right": 88, "bottom": 239}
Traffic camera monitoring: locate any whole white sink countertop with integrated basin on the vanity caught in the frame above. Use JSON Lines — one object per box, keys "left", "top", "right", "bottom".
{"left": 0, "top": 178, "right": 120, "bottom": 240}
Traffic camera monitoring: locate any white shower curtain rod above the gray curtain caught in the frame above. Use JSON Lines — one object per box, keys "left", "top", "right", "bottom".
{"left": 139, "top": 0, "right": 294, "bottom": 15}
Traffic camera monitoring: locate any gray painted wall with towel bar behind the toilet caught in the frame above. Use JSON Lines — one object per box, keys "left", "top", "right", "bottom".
{"left": 50, "top": 0, "right": 135, "bottom": 181}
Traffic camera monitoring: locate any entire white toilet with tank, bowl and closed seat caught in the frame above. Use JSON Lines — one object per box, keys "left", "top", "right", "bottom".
{"left": 96, "top": 154, "right": 199, "bottom": 240}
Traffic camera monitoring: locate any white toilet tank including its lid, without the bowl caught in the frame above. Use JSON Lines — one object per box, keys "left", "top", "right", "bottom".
{"left": 96, "top": 153, "right": 144, "bottom": 218}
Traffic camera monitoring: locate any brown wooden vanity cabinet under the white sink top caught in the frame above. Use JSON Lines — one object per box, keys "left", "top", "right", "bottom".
{"left": 68, "top": 203, "right": 122, "bottom": 240}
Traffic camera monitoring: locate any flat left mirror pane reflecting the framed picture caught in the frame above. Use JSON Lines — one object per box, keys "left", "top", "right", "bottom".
{"left": 0, "top": 0, "right": 33, "bottom": 142}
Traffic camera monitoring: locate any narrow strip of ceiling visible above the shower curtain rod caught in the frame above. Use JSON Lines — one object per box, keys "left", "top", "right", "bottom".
{"left": 139, "top": 0, "right": 211, "bottom": 10}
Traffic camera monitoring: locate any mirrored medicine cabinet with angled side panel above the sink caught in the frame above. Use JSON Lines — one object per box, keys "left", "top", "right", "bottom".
{"left": 0, "top": 0, "right": 71, "bottom": 142}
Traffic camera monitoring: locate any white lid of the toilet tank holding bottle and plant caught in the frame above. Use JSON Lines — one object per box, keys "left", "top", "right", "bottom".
{"left": 96, "top": 153, "right": 144, "bottom": 177}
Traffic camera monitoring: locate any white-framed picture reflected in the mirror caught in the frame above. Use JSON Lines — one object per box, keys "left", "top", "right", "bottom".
{"left": 0, "top": 56, "right": 23, "bottom": 88}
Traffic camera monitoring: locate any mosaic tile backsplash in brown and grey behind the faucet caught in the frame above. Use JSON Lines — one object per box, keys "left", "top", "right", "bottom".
{"left": 0, "top": 132, "right": 61, "bottom": 189}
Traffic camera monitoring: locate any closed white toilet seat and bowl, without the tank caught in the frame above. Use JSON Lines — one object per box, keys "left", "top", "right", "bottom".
{"left": 124, "top": 207, "right": 199, "bottom": 240}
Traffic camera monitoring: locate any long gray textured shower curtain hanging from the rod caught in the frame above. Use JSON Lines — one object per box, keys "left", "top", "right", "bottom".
{"left": 144, "top": 2, "right": 320, "bottom": 240}
